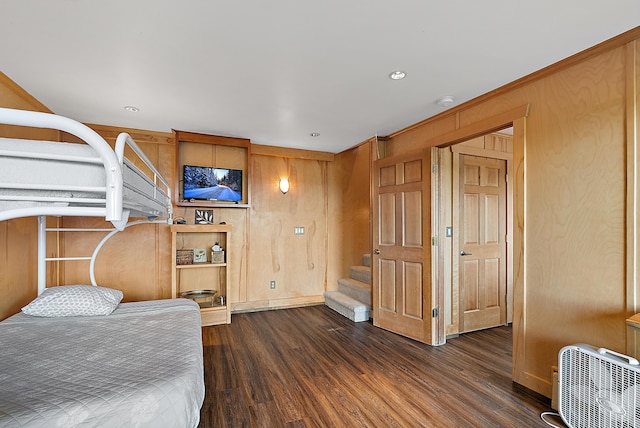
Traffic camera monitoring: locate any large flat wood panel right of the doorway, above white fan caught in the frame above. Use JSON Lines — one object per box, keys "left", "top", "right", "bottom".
{"left": 523, "top": 49, "right": 626, "bottom": 394}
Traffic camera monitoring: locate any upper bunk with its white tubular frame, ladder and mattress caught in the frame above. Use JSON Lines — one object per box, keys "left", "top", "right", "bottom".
{"left": 0, "top": 108, "right": 172, "bottom": 294}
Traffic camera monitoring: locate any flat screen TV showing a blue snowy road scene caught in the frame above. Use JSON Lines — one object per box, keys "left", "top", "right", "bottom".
{"left": 182, "top": 165, "right": 242, "bottom": 202}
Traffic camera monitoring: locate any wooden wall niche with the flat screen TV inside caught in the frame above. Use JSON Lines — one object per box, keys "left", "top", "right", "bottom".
{"left": 173, "top": 131, "right": 251, "bottom": 208}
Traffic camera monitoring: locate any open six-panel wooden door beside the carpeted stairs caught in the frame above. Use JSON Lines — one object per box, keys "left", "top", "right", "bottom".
{"left": 372, "top": 151, "right": 433, "bottom": 344}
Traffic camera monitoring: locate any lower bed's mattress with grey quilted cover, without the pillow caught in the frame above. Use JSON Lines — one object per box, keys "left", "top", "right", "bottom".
{"left": 0, "top": 299, "right": 204, "bottom": 427}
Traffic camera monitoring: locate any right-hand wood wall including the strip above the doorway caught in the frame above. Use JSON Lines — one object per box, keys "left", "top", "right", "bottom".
{"left": 380, "top": 28, "right": 640, "bottom": 396}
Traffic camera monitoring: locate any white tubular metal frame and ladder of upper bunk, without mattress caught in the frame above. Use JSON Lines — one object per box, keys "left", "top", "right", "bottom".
{"left": 0, "top": 108, "right": 172, "bottom": 295}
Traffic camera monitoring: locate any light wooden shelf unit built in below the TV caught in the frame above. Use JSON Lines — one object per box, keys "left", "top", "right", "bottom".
{"left": 171, "top": 224, "right": 231, "bottom": 326}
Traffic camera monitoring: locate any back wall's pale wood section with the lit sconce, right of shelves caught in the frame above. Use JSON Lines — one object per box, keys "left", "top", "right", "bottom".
{"left": 242, "top": 156, "right": 328, "bottom": 309}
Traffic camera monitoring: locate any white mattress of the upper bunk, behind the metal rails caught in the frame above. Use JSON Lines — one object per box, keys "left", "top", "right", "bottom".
{"left": 0, "top": 138, "right": 169, "bottom": 221}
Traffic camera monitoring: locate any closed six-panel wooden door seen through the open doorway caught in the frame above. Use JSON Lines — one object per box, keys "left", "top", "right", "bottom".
{"left": 458, "top": 155, "right": 507, "bottom": 333}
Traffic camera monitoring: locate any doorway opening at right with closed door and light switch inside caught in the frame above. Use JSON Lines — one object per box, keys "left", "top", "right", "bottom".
{"left": 432, "top": 128, "right": 513, "bottom": 336}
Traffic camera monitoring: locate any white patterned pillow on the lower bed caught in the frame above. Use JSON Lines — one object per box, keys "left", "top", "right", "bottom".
{"left": 22, "top": 285, "right": 123, "bottom": 317}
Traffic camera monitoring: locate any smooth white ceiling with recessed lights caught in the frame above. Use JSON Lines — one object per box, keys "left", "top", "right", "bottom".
{"left": 0, "top": 0, "right": 640, "bottom": 152}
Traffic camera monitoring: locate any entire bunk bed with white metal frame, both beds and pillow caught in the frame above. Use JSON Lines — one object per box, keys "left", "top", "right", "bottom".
{"left": 0, "top": 108, "right": 204, "bottom": 427}
